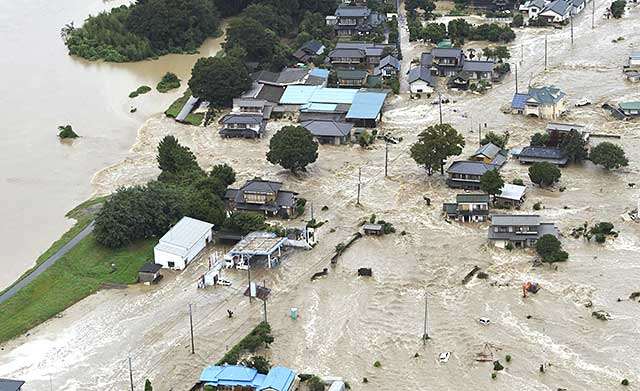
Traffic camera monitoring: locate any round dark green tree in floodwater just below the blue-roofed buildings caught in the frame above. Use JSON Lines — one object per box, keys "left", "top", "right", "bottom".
{"left": 267, "top": 126, "right": 318, "bottom": 174}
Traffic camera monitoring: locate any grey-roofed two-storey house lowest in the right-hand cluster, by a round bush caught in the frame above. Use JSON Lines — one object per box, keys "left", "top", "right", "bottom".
{"left": 488, "top": 215, "right": 559, "bottom": 248}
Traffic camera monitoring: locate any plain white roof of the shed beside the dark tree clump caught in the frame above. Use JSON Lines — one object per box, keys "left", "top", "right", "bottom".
{"left": 156, "top": 216, "right": 213, "bottom": 256}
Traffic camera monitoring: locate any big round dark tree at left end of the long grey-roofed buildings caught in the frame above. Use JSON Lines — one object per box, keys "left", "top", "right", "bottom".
{"left": 189, "top": 56, "right": 251, "bottom": 107}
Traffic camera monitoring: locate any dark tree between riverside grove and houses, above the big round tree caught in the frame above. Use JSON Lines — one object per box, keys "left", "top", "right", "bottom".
{"left": 223, "top": 17, "right": 277, "bottom": 62}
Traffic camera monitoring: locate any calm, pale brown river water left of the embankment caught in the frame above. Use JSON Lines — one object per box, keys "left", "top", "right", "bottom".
{"left": 0, "top": 0, "right": 221, "bottom": 289}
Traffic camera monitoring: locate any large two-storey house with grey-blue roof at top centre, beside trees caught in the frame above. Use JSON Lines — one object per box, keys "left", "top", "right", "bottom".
{"left": 327, "top": 5, "right": 386, "bottom": 37}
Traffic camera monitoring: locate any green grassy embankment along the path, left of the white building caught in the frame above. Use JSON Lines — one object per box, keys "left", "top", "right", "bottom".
{"left": 0, "top": 198, "right": 155, "bottom": 342}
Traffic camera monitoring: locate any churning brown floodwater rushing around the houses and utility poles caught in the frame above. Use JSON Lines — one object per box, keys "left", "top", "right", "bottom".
{"left": 0, "top": 3, "right": 640, "bottom": 391}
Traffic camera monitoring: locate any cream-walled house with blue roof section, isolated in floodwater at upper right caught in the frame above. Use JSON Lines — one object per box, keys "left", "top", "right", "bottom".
{"left": 511, "top": 86, "right": 567, "bottom": 119}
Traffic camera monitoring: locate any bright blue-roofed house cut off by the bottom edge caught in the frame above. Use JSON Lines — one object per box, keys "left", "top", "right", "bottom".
{"left": 199, "top": 365, "right": 299, "bottom": 391}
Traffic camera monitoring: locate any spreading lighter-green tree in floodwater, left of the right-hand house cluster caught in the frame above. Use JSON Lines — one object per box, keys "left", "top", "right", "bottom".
{"left": 411, "top": 124, "right": 464, "bottom": 175}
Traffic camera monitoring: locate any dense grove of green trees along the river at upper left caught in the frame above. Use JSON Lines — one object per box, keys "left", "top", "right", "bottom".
{"left": 61, "top": 0, "right": 219, "bottom": 62}
